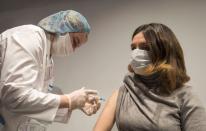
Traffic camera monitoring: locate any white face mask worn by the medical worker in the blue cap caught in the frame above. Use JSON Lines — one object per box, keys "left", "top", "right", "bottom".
{"left": 51, "top": 33, "right": 74, "bottom": 56}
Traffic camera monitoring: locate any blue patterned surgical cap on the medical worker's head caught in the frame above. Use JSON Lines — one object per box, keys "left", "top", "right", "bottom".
{"left": 38, "top": 10, "right": 91, "bottom": 35}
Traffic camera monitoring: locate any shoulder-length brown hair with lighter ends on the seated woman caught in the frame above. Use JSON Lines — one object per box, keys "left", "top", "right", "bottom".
{"left": 132, "top": 23, "right": 190, "bottom": 92}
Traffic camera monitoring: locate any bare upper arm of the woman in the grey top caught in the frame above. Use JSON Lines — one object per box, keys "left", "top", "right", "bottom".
{"left": 93, "top": 90, "right": 119, "bottom": 131}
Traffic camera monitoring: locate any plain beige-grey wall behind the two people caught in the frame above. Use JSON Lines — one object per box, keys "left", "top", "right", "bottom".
{"left": 0, "top": 0, "right": 206, "bottom": 131}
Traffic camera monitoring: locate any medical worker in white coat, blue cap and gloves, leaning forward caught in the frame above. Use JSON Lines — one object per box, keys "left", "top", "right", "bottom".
{"left": 0, "top": 10, "right": 100, "bottom": 131}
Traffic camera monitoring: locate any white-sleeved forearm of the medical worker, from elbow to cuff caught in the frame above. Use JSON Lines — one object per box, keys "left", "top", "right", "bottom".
{"left": 1, "top": 86, "right": 60, "bottom": 122}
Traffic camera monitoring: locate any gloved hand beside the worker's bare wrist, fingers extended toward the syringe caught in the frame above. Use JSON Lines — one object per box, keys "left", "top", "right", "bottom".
{"left": 66, "top": 87, "right": 97, "bottom": 110}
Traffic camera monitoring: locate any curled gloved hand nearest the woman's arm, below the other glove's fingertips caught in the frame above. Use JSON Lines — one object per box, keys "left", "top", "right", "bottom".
{"left": 81, "top": 95, "right": 101, "bottom": 116}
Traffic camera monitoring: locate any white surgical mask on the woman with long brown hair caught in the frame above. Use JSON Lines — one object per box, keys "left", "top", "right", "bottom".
{"left": 130, "top": 48, "right": 151, "bottom": 75}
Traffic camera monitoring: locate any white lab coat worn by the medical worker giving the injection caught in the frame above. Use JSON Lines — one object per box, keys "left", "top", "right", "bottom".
{"left": 0, "top": 25, "right": 69, "bottom": 131}
